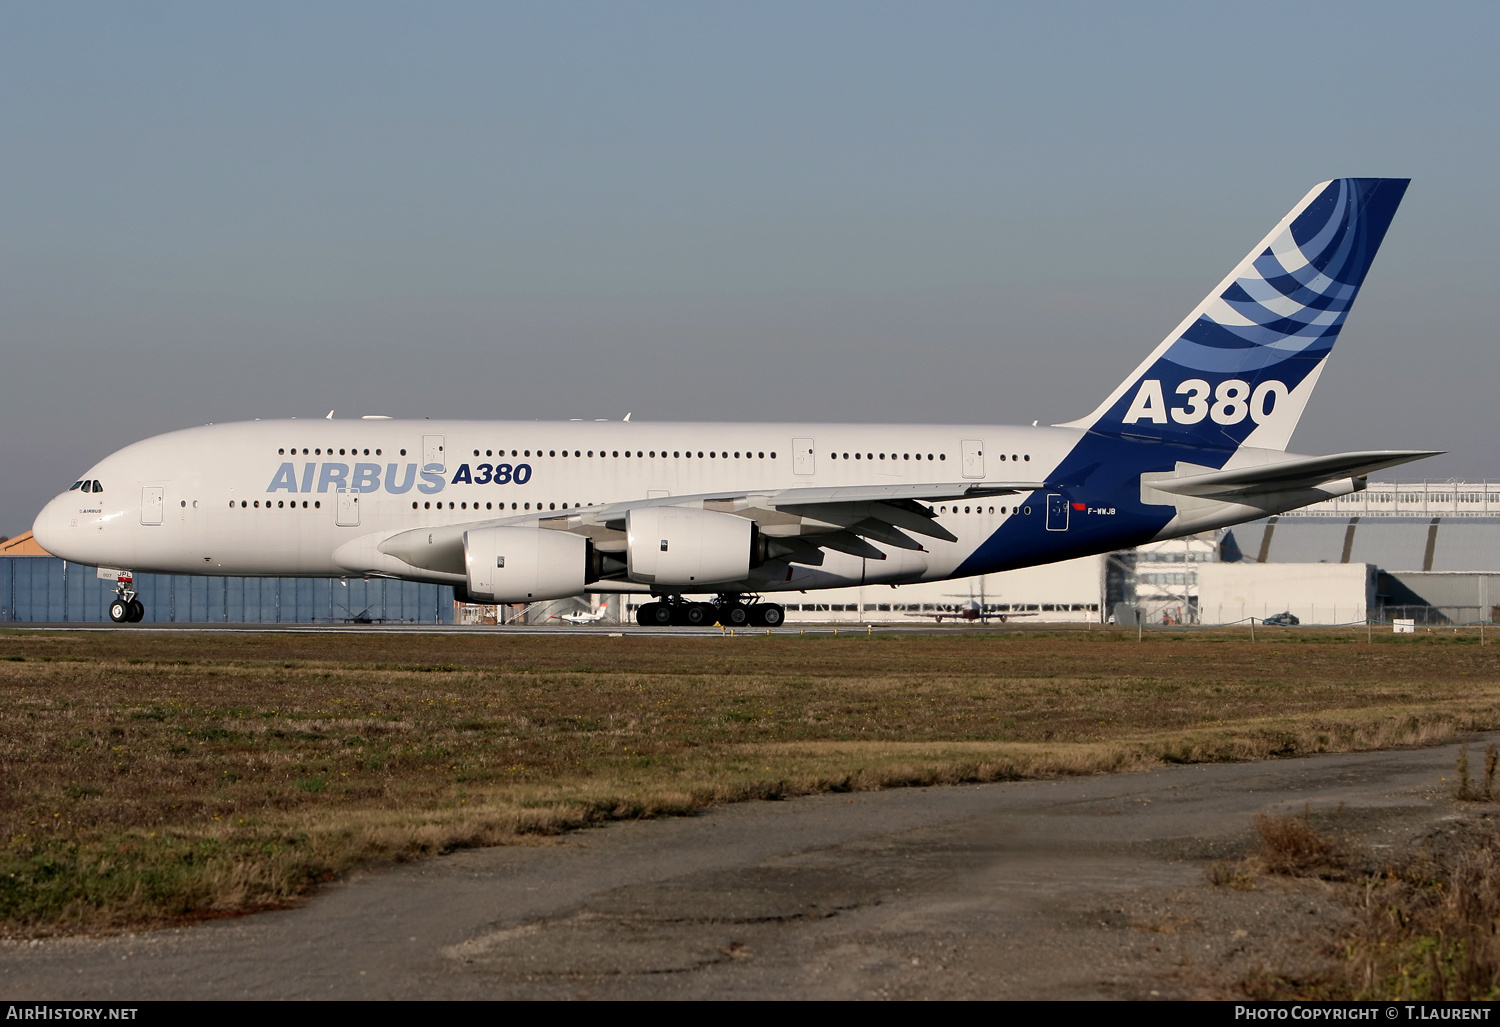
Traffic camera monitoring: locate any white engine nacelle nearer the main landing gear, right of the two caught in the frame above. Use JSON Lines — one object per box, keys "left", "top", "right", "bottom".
{"left": 626, "top": 507, "right": 756, "bottom": 588}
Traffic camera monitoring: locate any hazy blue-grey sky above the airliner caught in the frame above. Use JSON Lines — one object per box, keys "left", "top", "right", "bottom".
{"left": 0, "top": 3, "right": 1500, "bottom": 534}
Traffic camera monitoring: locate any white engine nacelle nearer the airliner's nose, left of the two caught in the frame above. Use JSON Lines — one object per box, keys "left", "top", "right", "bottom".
{"left": 464, "top": 528, "right": 588, "bottom": 603}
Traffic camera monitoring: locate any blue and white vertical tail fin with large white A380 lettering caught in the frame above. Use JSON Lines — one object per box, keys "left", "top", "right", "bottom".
{"left": 1059, "top": 178, "right": 1410, "bottom": 450}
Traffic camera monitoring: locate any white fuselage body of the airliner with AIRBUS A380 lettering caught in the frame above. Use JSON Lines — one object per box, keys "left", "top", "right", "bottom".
{"left": 35, "top": 418, "right": 1082, "bottom": 591}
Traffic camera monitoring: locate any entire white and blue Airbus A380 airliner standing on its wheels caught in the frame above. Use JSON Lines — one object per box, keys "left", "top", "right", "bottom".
{"left": 35, "top": 178, "right": 1434, "bottom": 625}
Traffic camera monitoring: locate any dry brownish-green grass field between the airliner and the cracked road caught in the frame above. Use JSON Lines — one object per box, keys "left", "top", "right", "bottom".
{"left": 0, "top": 630, "right": 1500, "bottom": 936}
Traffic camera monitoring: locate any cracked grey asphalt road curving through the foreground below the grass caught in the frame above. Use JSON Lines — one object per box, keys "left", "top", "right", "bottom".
{"left": 0, "top": 739, "right": 1488, "bottom": 1000}
